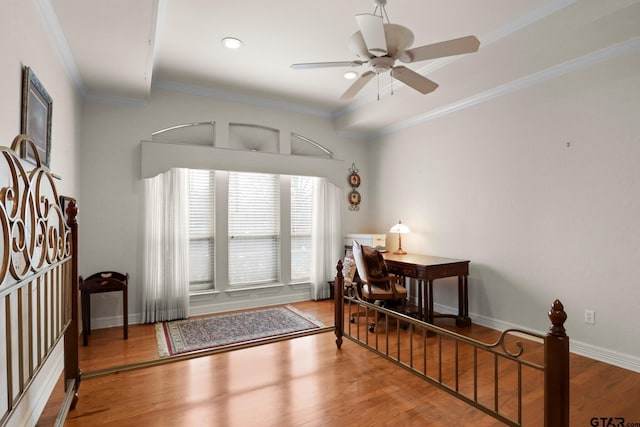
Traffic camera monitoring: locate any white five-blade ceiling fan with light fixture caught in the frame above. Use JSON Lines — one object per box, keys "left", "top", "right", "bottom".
{"left": 291, "top": 0, "right": 480, "bottom": 100}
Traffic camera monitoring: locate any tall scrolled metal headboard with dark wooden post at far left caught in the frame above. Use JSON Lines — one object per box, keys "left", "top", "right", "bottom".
{"left": 0, "top": 135, "right": 80, "bottom": 426}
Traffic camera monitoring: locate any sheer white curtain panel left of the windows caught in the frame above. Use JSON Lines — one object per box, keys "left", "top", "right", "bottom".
{"left": 142, "top": 169, "right": 189, "bottom": 323}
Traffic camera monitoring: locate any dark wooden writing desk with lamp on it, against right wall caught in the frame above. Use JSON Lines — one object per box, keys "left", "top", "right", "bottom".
{"left": 382, "top": 253, "right": 471, "bottom": 326}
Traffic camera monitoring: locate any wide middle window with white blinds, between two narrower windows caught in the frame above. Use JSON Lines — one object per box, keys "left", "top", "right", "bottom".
{"left": 228, "top": 172, "right": 280, "bottom": 286}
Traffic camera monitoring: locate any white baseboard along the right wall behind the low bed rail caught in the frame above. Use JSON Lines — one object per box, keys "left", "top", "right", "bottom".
{"left": 433, "top": 304, "right": 640, "bottom": 372}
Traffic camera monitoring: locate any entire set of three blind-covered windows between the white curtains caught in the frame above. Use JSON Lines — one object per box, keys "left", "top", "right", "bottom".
{"left": 189, "top": 170, "right": 314, "bottom": 293}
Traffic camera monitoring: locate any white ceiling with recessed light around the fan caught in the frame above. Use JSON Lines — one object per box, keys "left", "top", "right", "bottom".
{"left": 46, "top": 0, "right": 640, "bottom": 134}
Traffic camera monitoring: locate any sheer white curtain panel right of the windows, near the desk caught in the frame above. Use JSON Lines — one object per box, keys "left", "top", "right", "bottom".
{"left": 311, "top": 178, "right": 344, "bottom": 300}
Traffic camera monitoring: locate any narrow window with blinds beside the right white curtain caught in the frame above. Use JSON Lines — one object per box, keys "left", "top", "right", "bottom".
{"left": 291, "top": 176, "right": 313, "bottom": 281}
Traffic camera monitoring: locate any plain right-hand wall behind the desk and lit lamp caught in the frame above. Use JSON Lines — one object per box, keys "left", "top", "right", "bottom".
{"left": 368, "top": 53, "right": 640, "bottom": 369}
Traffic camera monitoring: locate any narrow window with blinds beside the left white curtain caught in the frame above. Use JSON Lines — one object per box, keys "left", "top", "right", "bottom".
{"left": 189, "top": 169, "right": 215, "bottom": 292}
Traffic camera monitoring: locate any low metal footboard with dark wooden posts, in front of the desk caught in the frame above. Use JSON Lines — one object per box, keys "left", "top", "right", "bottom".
{"left": 334, "top": 261, "right": 569, "bottom": 427}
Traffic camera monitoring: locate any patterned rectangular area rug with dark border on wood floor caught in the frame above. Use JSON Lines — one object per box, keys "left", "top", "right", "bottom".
{"left": 156, "top": 306, "right": 324, "bottom": 357}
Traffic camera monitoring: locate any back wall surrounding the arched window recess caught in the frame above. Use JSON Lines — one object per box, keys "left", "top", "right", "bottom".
{"left": 80, "top": 88, "right": 368, "bottom": 327}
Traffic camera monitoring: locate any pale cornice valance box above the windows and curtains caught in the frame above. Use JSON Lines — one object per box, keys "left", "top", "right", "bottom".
{"left": 140, "top": 141, "right": 345, "bottom": 187}
